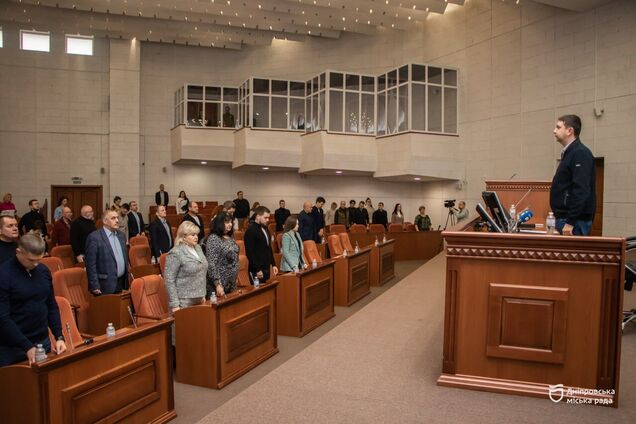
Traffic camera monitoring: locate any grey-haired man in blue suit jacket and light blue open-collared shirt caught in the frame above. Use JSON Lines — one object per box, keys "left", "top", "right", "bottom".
{"left": 84, "top": 210, "right": 128, "bottom": 296}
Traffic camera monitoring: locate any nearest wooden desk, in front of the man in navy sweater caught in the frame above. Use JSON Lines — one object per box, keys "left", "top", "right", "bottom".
{"left": 0, "top": 319, "right": 176, "bottom": 424}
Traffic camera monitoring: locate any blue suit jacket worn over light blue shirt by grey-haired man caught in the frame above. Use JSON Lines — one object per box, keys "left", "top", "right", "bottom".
{"left": 84, "top": 228, "right": 128, "bottom": 294}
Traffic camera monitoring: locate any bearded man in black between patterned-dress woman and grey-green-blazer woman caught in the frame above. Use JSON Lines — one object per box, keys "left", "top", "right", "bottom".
{"left": 243, "top": 206, "right": 278, "bottom": 281}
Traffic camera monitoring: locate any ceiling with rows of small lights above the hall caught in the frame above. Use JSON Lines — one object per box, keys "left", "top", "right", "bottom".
{"left": 0, "top": 0, "right": 464, "bottom": 49}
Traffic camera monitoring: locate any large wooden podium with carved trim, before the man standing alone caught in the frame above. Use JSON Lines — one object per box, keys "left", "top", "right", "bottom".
{"left": 438, "top": 181, "right": 625, "bottom": 406}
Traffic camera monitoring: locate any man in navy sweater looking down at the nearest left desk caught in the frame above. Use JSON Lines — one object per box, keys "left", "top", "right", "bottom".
{"left": 0, "top": 234, "right": 66, "bottom": 366}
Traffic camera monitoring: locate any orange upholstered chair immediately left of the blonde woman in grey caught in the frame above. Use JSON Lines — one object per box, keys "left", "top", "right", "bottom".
{"left": 130, "top": 275, "right": 169, "bottom": 322}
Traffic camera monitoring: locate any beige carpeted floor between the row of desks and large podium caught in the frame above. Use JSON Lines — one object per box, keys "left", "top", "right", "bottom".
{"left": 195, "top": 255, "right": 636, "bottom": 424}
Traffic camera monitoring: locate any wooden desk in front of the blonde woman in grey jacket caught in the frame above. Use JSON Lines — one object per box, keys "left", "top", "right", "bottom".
{"left": 174, "top": 281, "right": 278, "bottom": 389}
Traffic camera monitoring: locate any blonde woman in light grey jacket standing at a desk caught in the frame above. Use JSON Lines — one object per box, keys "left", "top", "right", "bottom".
{"left": 164, "top": 221, "right": 208, "bottom": 312}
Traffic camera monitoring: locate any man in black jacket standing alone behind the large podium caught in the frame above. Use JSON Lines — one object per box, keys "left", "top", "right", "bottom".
{"left": 550, "top": 115, "right": 596, "bottom": 236}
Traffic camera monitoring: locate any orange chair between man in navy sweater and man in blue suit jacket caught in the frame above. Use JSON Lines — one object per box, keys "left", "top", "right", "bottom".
{"left": 53, "top": 268, "right": 91, "bottom": 333}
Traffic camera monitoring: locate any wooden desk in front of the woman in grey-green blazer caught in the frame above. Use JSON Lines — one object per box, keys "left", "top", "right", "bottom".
{"left": 276, "top": 260, "right": 335, "bottom": 337}
